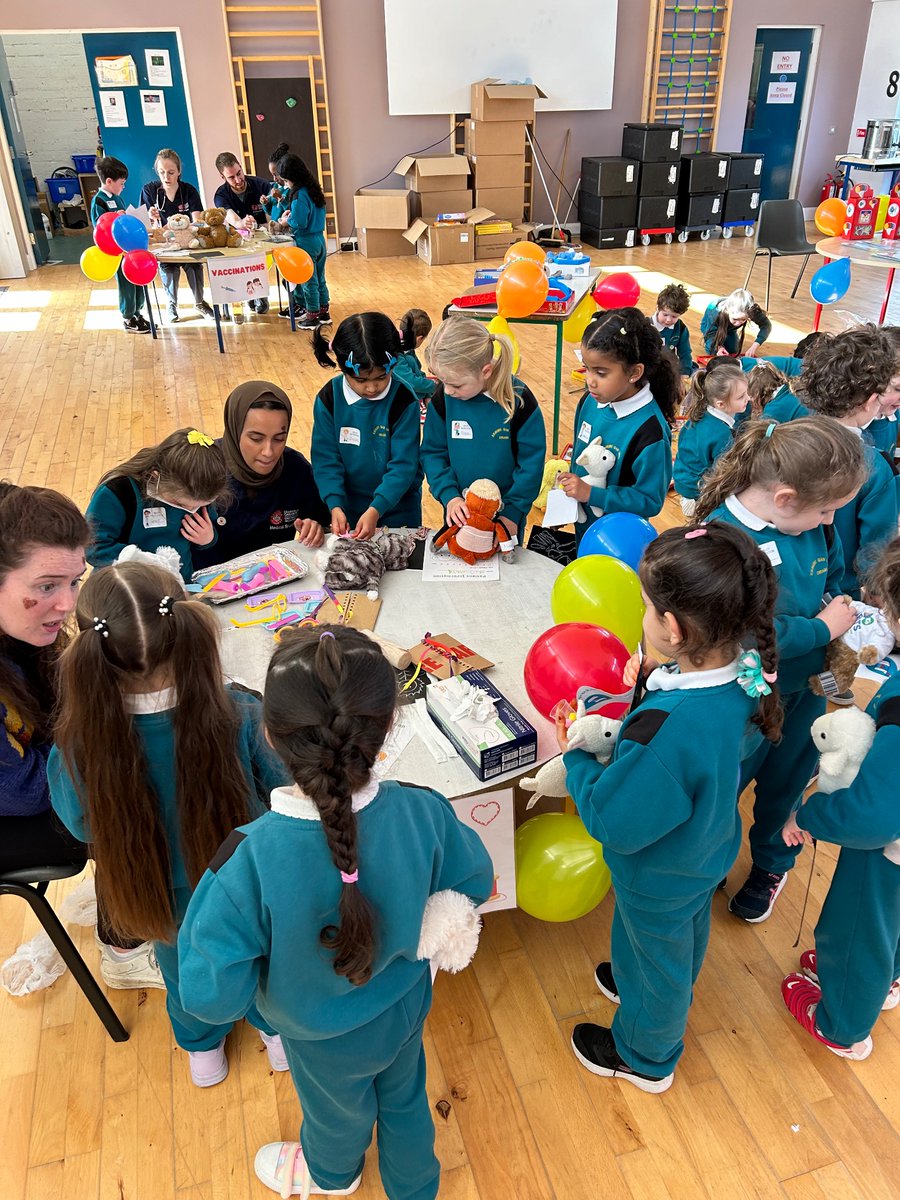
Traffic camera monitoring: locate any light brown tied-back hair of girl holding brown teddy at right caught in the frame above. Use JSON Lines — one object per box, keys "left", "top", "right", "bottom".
{"left": 695, "top": 416, "right": 866, "bottom": 521}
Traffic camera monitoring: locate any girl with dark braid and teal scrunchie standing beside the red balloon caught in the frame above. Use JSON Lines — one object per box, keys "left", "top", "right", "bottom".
{"left": 566, "top": 522, "right": 781, "bottom": 1092}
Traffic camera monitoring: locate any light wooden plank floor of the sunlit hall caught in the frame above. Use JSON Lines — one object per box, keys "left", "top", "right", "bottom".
{"left": 0, "top": 226, "right": 900, "bottom": 1200}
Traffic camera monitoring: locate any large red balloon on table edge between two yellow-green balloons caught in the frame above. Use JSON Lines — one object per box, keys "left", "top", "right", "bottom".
{"left": 524, "top": 620, "right": 631, "bottom": 719}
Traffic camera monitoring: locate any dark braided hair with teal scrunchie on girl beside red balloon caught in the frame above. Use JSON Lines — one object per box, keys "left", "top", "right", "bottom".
{"left": 640, "top": 521, "right": 784, "bottom": 742}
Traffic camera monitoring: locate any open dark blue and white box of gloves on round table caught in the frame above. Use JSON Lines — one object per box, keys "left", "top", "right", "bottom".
{"left": 425, "top": 671, "right": 538, "bottom": 781}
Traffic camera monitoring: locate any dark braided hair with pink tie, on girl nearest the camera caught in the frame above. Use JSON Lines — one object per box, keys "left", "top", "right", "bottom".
{"left": 263, "top": 625, "right": 397, "bottom": 984}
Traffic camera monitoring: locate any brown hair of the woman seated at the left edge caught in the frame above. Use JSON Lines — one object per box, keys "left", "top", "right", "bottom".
{"left": 0, "top": 479, "right": 91, "bottom": 739}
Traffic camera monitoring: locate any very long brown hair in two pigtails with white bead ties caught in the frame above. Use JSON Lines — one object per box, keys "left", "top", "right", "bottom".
{"left": 56, "top": 563, "right": 251, "bottom": 941}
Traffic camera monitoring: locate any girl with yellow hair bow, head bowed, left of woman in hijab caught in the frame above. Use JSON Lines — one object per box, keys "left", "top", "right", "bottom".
{"left": 85, "top": 428, "right": 228, "bottom": 582}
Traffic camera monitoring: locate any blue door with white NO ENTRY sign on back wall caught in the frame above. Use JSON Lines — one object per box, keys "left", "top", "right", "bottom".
{"left": 743, "top": 29, "right": 814, "bottom": 200}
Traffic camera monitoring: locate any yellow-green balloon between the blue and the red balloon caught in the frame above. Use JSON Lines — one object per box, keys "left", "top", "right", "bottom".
{"left": 550, "top": 554, "right": 644, "bottom": 650}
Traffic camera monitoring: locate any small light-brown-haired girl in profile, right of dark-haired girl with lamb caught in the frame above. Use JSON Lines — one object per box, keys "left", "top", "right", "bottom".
{"left": 672, "top": 362, "right": 749, "bottom": 516}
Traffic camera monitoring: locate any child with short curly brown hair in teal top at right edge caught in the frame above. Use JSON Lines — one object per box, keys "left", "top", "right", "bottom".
{"left": 801, "top": 325, "right": 900, "bottom": 600}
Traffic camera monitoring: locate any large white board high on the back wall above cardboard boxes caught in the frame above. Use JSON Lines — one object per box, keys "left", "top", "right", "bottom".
{"left": 384, "top": 0, "right": 618, "bottom": 116}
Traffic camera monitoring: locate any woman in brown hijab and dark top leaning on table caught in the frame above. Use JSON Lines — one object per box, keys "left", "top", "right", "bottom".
{"left": 194, "top": 379, "right": 331, "bottom": 566}
